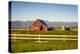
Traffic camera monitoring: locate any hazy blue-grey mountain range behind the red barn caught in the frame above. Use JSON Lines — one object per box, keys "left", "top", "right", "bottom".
{"left": 9, "top": 21, "right": 78, "bottom": 28}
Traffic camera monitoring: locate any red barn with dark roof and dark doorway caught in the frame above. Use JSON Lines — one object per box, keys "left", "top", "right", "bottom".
{"left": 29, "top": 19, "right": 48, "bottom": 31}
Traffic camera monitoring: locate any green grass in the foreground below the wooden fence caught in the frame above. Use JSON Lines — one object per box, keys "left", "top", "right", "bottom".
{"left": 11, "top": 40, "right": 78, "bottom": 53}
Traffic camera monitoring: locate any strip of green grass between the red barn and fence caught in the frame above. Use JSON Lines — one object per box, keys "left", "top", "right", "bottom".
{"left": 11, "top": 30, "right": 78, "bottom": 35}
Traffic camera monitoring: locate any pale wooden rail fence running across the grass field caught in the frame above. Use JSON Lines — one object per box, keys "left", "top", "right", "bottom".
{"left": 9, "top": 34, "right": 78, "bottom": 41}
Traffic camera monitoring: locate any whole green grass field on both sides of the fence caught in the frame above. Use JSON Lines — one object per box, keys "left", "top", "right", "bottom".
{"left": 9, "top": 30, "right": 78, "bottom": 53}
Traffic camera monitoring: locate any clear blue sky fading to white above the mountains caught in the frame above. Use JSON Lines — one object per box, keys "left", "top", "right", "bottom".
{"left": 11, "top": 2, "right": 78, "bottom": 22}
